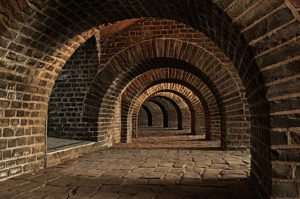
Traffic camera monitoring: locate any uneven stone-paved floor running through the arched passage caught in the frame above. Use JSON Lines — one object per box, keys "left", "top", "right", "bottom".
{"left": 0, "top": 130, "right": 258, "bottom": 199}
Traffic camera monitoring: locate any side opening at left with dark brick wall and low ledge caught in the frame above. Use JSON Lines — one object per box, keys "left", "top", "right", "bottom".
{"left": 46, "top": 36, "right": 99, "bottom": 162}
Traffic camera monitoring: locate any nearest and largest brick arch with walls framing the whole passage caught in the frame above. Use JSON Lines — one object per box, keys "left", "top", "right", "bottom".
{"left": 0, "top": 0, "right": 299, "bottom": 198}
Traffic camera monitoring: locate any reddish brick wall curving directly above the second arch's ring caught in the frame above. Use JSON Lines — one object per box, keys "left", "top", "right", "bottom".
{"left": 100, "top": 18, "right": 244, "bottom": 98}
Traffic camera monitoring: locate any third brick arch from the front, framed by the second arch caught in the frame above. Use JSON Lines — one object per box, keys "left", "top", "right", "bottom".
{"left": 122, "top": 68, "right": 214, "bottom": 141}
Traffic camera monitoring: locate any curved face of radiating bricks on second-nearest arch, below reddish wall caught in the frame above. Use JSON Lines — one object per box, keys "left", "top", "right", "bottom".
{"left": 83, "top": 39, "right": 249, "bottom": 145}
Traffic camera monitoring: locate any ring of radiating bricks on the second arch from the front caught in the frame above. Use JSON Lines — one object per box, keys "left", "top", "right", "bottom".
{"left": 86, "top": 39, "right": 249, "bottom": 148}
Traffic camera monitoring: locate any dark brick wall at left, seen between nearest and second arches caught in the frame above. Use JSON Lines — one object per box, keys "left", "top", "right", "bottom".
{"left": 47, "top": 37, "right": 99, "bottom": 140}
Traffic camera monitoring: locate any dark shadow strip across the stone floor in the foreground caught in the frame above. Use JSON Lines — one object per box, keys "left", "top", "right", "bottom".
{"left": 0, "top": 173, "right": 258, "bottom": 199}
